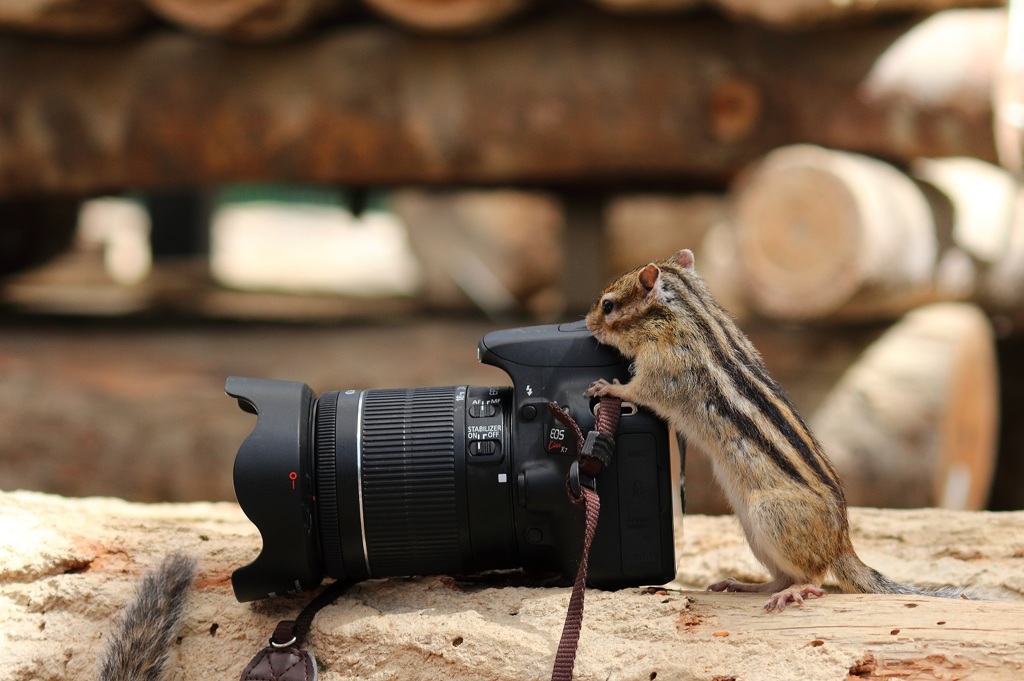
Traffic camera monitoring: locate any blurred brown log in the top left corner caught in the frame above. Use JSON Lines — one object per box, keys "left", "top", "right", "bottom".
{"left": 0, "top": 0, "right": 153, "bottom": 38}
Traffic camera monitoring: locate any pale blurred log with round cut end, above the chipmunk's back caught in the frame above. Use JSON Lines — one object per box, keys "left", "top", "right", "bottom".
{"left": 733, "top": 145, "right": 937, "bottom": 320}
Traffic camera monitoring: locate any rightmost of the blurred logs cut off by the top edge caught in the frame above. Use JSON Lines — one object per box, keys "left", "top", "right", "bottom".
{"left": 707, "top": 0, "right": 1005, "bottom": 29}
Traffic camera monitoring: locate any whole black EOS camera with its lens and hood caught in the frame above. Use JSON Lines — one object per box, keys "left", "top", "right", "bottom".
{"left": 225, "top": 323, "right": 682, "bottom": 601}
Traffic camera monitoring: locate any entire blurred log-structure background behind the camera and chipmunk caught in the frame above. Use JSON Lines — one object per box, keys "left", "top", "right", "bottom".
{"left": 0, "top": 0, "right": 1024, "bottom": 512}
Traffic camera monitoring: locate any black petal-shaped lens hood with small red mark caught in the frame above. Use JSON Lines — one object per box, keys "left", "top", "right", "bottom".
{"left": 224, "top": 376, "right": 324, "bottom": 601}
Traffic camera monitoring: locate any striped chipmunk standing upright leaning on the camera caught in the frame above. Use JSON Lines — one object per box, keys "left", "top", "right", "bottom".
{"left": 586, "top": 249, "right": 963, "bottom": 612}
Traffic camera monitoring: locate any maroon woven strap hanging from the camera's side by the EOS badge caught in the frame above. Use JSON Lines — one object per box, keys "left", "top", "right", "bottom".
{"left": 548, "top": 397, "right": 623, "bottom": 681}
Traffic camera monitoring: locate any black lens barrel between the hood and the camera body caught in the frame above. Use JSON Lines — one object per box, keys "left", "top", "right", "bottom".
{"left": 312, "top": 386, "right": 515, "bottom": 580}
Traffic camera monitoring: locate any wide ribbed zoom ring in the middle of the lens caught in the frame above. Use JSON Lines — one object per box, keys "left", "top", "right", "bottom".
{"left": 362, "top": 387, "right": 461, "bottom": 577}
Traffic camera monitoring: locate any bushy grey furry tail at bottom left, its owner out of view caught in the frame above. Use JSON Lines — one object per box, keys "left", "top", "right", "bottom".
{"left": 99, "top": 553, "right": 196, "bottom": 681}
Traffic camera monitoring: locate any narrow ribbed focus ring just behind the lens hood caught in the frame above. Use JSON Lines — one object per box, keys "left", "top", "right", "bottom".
{"left": 313, "top": 392, "right": 344, "bottom": 574}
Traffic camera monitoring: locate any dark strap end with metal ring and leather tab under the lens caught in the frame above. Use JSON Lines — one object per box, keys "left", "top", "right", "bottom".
{"left": 241, "top": 580, "right": 351, "bottom": 681}
